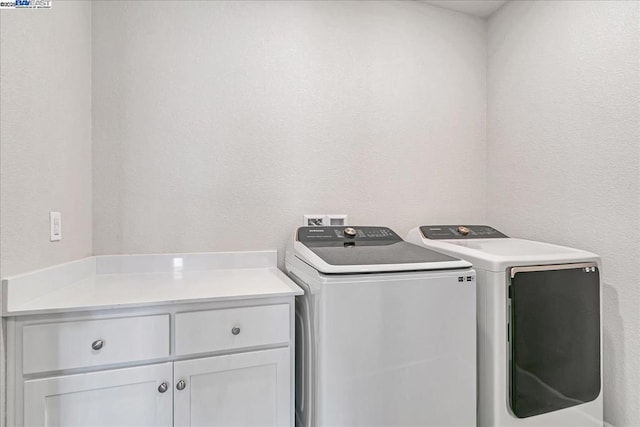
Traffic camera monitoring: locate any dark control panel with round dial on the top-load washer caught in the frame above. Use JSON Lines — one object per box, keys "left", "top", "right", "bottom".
{"left": 298, "top": 226, "right": 402, "bottom": 246}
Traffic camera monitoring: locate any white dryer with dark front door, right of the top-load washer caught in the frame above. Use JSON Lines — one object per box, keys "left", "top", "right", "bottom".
{"left": 406, "top": 225, "right": 603, "bottom": 427}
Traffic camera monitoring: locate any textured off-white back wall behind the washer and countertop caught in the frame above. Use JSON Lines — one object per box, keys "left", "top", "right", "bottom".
{"left": 93, "top": 1, "right": 486, "bottom": 260}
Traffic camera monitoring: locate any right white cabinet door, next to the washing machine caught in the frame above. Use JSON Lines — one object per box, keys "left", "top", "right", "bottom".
{"left": 174, "top": 348, "right": 292, "bottom": 427}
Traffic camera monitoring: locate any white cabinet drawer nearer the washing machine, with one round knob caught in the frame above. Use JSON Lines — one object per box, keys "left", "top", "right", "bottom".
{"left": 175, "top": 304, "right": 289, "bottom": 356}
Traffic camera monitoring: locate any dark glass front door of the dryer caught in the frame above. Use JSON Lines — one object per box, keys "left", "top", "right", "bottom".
{"left": 509, "top": 263, "right": 600, "bottom": 418}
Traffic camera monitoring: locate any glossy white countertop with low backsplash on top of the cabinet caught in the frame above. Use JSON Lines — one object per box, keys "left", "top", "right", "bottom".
{"left": 2, "top": 251, "right": 303, "bottom": 317}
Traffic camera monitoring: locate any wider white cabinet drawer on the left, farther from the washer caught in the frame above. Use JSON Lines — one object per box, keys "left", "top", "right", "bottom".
{"left": 22, "top": 314, "right": 169, "bottom": 374}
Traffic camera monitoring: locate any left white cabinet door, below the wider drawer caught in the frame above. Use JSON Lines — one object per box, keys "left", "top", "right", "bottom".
{"left": 24, "top": 363, "right": 173, "bottom": 427}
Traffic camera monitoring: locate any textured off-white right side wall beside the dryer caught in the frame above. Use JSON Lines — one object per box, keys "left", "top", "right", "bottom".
{"left": 486, "top": 1, "right": 640, "bottom": 427}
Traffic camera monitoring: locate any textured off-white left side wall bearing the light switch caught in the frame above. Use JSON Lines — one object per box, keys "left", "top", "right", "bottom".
{"left": 0, "top": 1, "right": 92, "bottom": 425}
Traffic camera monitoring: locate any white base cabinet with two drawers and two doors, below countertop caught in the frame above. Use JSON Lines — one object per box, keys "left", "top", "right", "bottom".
{"left": 8, "top": 297, "right": 294, "bottom": 427}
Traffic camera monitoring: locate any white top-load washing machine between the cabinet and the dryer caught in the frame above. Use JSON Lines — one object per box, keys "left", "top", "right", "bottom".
{"left": 285, "top": 226, "right": 476, "bottom": 427}
